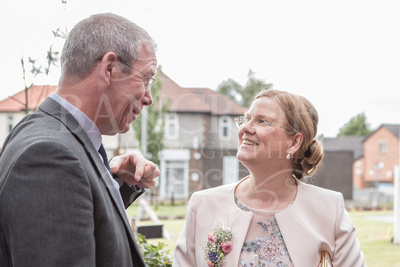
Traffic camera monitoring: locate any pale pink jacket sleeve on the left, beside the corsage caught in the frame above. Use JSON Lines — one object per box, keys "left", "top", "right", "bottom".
{"left": 172, "top": 193, "right": 197, "bottom": 267}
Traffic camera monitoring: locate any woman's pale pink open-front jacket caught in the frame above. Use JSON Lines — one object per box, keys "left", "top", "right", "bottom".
{"left": 172, "top": 181, "right": 365, "bottom": 267}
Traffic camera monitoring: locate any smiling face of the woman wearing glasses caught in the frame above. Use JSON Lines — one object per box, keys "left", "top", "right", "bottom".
{"left": 237, "top": 97, "right": 291, "bottom": 167}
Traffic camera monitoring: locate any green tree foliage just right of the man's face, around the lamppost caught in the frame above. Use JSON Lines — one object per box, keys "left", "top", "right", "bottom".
{"left": 132, "top": 68, "right": 168, "bottom": 164}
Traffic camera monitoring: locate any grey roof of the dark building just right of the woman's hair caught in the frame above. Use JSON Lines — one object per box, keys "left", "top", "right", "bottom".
{"left": 322, "top": 136, "right": 365, "bottom": 160}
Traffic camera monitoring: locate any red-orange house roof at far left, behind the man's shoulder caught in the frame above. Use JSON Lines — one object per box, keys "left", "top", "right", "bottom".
{"left": 0, "top": 85, "right": 57, "bottom": 112}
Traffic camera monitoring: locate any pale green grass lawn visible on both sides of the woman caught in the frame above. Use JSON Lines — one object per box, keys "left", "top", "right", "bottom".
{"left": 127, "top": 205, "right": 400, "bottom": 267}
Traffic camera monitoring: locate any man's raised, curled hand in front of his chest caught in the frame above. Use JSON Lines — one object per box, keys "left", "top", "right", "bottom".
{"left": 110, "top": 152, "right": 160, "bottom": 188}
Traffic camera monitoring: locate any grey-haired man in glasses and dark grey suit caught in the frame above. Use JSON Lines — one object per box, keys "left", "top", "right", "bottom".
{"left": 0, "top": 14, "right": 160, "bottom": 267}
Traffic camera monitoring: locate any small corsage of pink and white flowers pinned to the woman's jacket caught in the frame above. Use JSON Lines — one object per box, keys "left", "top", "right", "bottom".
{"left": 200, "top": 221, "right": 233, "bottom": 267}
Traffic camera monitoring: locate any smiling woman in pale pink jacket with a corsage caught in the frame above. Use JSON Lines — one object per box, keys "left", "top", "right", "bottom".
{"left": 173, "top": 90, "right": 365, "bottom": 267}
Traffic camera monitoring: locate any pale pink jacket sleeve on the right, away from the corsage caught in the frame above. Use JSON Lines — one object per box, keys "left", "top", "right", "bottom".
{"left": 332, "top": 194, "right": 365, "bottom": 267}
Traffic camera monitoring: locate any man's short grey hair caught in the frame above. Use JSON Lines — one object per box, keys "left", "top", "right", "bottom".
{"left": 60, "top": 13, "right": 156, "bottom": 82}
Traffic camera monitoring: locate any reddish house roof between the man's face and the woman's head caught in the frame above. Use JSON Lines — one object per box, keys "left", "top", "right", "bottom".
{"left": 159, "top": 72, "right": 247, "bottom": 115}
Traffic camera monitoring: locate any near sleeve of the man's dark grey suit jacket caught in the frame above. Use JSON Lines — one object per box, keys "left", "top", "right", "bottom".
{"left": 0, "top": 141, "right": 96, "bottom": 266}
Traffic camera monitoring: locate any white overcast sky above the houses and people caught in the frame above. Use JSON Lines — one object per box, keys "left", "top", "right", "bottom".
{"left": 0, "top": 0, "right": 400, "bottom": 137}
